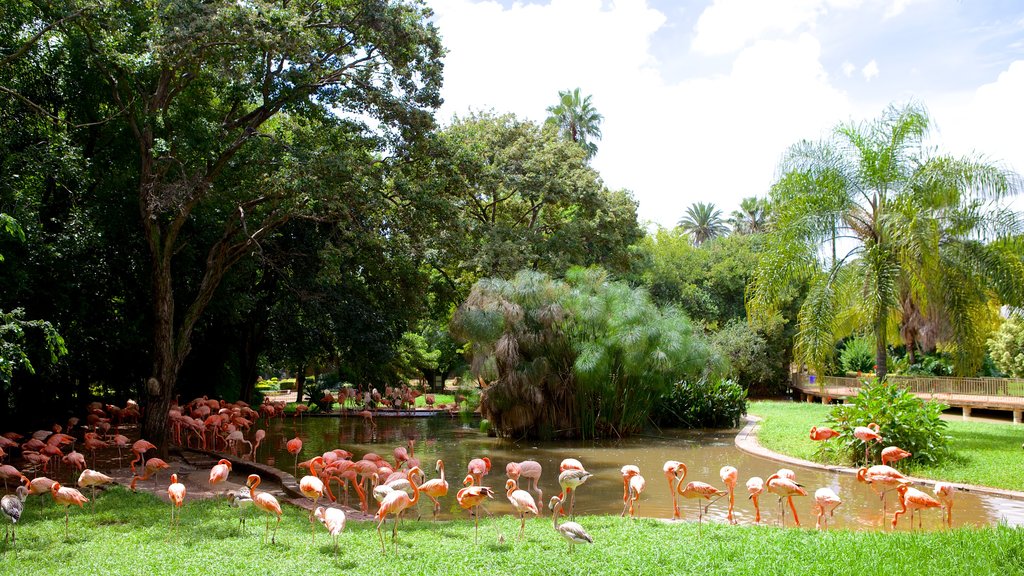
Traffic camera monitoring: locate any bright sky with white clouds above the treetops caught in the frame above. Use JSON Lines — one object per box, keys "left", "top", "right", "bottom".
{"left": 426, "top": 0, "right": 1024, "bottom": 228}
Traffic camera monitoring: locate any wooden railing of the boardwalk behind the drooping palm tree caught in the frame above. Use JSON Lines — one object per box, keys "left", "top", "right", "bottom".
{"left": 793, "top": 374, "right": 1024, "bottom": 397}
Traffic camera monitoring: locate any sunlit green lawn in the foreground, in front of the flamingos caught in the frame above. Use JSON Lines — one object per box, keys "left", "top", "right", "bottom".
{"left": 0, "top": 488, "right": 1024, "bottom": 576}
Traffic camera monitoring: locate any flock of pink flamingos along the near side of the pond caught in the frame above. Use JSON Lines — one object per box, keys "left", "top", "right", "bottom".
{"left": 0, "top": 391, "right": 954, "bottom": 554}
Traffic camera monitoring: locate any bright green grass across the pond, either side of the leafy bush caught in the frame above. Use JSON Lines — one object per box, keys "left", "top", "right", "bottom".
{"left": 750, "top": 402, "right": 1024, "bottom": 490}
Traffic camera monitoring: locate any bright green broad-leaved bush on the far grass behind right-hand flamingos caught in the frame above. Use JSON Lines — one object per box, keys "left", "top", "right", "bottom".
{"left": 818, "top": 381, "right": 949, "bottom": 465}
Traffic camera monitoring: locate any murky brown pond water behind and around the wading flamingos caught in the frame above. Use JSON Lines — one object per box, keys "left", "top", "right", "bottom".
{"left": 259, "top": 416, "right": 1024, "bottom": 530}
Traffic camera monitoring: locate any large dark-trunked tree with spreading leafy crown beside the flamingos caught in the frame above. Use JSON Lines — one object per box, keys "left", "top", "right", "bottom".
{"left": 0, "top": 0, "right": 442, "bottom": 444}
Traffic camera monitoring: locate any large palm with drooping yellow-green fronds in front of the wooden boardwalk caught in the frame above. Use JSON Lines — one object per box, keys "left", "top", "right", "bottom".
{"left": 748, "top": 102, "right": 1024, "bottom": 378}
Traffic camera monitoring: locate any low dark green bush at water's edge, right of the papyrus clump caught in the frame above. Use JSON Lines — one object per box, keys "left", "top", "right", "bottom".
{"left": 657, "top": 379, "right": 746, "bottom": 428}
